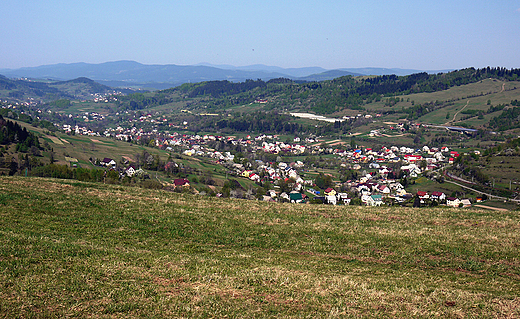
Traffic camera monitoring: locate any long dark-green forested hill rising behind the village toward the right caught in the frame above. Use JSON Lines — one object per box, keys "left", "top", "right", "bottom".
{"left": 117, "top": 67, "right": 520, "bottom": 114}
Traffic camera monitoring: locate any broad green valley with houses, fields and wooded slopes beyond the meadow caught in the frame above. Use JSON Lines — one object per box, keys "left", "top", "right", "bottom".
{"left": 3, "top": 69, "right": 520, "bottom": 209}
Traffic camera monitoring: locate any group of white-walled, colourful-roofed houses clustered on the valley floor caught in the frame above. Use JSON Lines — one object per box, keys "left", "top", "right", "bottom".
{"left": 85, "top": 124, "right": 480, "bottom": 207}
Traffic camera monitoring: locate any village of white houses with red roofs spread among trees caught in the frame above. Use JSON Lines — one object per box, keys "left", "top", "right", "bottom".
{"left": 79, "top": 120, "right": 481, "bottom": 207}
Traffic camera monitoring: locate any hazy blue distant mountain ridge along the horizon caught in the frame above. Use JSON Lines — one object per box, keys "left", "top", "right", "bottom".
{"left": 0, "top": 61, "right": 450, "bottom": 89}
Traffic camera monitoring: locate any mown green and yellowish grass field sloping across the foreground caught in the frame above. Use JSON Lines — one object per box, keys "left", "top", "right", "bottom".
{"left": 0, "top": 177, "right": 520, "bottom": 318}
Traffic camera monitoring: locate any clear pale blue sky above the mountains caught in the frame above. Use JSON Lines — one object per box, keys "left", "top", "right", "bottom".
{"left": 0, "top": 0, "right": 520, "bottom": 70}
